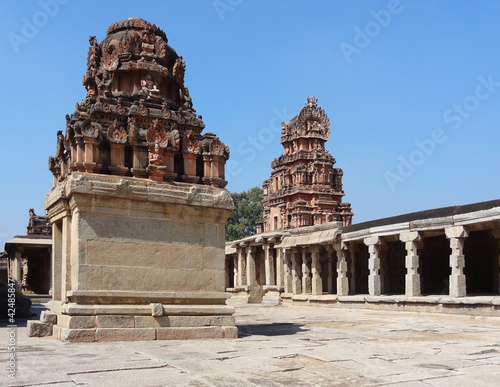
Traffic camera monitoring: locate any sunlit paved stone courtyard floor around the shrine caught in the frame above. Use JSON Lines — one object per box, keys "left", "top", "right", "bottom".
{"left": 0, "top": 305, "right": 500, "bottom": 387}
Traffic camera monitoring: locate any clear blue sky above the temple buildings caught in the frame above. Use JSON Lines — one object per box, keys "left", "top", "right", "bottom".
{"left": 0, "top": 0, "right": 500, "bottom": 249}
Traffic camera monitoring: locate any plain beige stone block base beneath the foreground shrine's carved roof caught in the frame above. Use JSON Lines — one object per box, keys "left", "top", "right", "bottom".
{"left": 29, "top": 173, "right": 238, "bottom": 342}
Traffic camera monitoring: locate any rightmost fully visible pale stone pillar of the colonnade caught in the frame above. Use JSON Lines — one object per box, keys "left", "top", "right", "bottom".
{"left": 444, "top": 226, "right": 469, "bottom": 297}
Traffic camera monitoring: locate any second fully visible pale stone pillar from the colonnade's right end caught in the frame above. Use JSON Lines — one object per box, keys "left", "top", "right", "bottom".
{"left": 399, "top": 231, "right": 422, "bottom": 297}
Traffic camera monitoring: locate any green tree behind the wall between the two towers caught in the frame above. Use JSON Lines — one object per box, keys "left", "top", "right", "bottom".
{"left": 226, "top": 187, "right": 264, "bottom": 241}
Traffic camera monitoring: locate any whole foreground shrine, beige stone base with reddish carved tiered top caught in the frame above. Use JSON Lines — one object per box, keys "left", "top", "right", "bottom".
{"left": 29, "top": 18, "right": 237, "bottom": 341}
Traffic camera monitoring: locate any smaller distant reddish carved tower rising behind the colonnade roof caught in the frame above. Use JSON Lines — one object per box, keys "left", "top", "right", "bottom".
{"left": 263, "top": 96, "right": 353, "bottom": 232}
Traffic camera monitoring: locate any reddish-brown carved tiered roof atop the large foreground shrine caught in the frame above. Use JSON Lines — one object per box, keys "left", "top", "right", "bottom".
{"left": 49, "top": 18, "right": 229, "bottom": 187}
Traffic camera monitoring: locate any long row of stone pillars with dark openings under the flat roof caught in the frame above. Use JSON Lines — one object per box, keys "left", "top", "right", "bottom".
{"left": 227, "top": 226, "right": 500, "bottom": 297}
